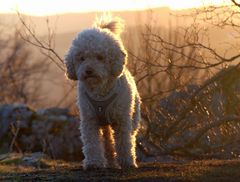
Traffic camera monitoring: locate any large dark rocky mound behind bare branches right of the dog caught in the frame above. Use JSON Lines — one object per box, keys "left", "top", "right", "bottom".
{"left": 148, "top": 67, "right": 240, "bottom": 156}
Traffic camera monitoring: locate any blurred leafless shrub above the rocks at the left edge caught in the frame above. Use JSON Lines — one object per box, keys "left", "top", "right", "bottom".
{"left": 0, "top": 27, "right": 47, "bottom": 105}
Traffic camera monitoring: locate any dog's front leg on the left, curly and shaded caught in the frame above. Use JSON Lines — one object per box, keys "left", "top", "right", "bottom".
{"left": 80, "top": 119, "right": 106, "bottom": 169}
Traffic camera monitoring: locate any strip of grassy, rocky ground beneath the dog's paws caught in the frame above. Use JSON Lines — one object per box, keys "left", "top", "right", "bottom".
{"left": 0, "top": 154, "right": 240, "bottom": 182}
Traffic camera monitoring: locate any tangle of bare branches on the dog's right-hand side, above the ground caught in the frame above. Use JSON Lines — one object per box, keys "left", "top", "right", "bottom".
{"left": 125, "top": 5, "right": 240, "bottom": 157}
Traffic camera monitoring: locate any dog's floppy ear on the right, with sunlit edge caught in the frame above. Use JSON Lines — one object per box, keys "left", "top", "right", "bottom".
{"left": 111, "top": 51, "right": 127, "bottom": 77}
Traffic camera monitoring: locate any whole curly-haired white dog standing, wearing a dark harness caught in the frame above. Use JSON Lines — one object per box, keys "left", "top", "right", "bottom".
{"left": 65, "top": 18, "right": 141, "bottom": 169}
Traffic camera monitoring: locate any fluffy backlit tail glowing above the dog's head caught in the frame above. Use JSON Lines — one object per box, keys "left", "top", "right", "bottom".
{"left": 94, "top": 14, "right": 124, "bottom": 35}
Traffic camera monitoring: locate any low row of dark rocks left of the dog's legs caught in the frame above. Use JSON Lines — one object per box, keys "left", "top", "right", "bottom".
{"left": 0, "top": 104, "right": 83, "bottom": 160}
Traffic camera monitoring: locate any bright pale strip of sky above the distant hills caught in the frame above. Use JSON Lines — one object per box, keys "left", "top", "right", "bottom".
{"left": 0, "top": 0, "right": 230, "bottom": 16}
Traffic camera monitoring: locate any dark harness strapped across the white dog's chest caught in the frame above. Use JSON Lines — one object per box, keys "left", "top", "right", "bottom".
{"left": 85, "top": 92, "right": 117, "bottom": 126}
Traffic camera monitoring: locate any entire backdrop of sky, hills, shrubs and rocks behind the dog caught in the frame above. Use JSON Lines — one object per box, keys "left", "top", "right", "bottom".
{"left": 0, "top": 0, "right": 240, "bottom": 161}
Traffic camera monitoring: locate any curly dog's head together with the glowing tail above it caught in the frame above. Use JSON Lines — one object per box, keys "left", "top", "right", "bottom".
{"left": 65, "top": 15, "right": 127, "bottom": 84}
